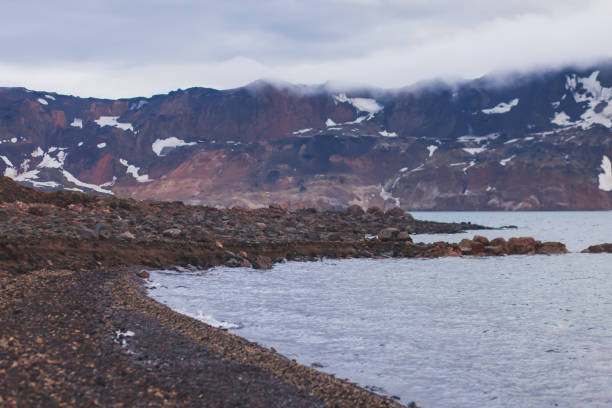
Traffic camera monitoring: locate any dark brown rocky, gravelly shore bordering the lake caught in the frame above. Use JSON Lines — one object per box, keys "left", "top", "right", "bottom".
{"left": 0, "top": 177, "right": 609, "bottom": 407}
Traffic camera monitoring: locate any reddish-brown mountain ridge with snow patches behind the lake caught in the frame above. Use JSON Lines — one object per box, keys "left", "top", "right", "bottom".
{"left": 0, "top": 64, "right": 612, "bottom": 210}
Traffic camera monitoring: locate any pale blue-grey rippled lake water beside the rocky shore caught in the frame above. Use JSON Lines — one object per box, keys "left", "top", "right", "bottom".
{"left": 149, "top": 212, "right": 612, "bottom": 407}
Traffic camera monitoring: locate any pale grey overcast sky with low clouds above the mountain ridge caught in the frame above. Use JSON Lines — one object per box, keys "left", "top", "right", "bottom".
{"left": 0, "top": 0, "right": 612, "bottom": 98}
